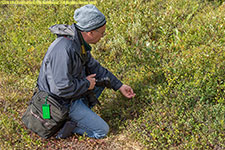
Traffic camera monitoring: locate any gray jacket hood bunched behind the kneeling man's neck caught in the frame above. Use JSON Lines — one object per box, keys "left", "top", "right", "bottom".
{"left": 48, "top": 24, "right": 76, "bottom": 37}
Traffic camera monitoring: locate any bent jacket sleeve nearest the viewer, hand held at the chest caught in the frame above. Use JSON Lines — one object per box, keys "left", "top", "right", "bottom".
{"left": 45, "top": 46, "right": 90, "bottom": 98}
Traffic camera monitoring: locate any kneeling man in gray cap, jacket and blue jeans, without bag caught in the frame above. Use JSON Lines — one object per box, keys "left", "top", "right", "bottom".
{"left": 37, "top": 5, "right": 135, "bottom": 139}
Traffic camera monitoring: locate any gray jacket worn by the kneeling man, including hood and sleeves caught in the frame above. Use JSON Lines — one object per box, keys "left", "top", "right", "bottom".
{"left": 37, "top": 24, "right": 122, "bottom": 99}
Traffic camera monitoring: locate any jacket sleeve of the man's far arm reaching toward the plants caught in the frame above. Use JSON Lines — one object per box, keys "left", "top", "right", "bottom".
{"left": 87, "top": 52, "right": 123, "bottom": 91}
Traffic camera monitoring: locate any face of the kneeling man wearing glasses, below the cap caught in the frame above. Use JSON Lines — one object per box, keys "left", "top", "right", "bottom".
{"left": 83, "top": 25, "right": 106, "bottom": 44}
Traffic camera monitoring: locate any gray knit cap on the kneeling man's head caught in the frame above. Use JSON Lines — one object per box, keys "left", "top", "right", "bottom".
{"left": 73, "top": 4, "right": 106, "bottom": 32}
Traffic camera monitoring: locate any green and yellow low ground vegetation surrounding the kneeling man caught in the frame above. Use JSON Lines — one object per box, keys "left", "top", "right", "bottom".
{"left": 0, "top": 0, "right": 225, "bottom": 149}
